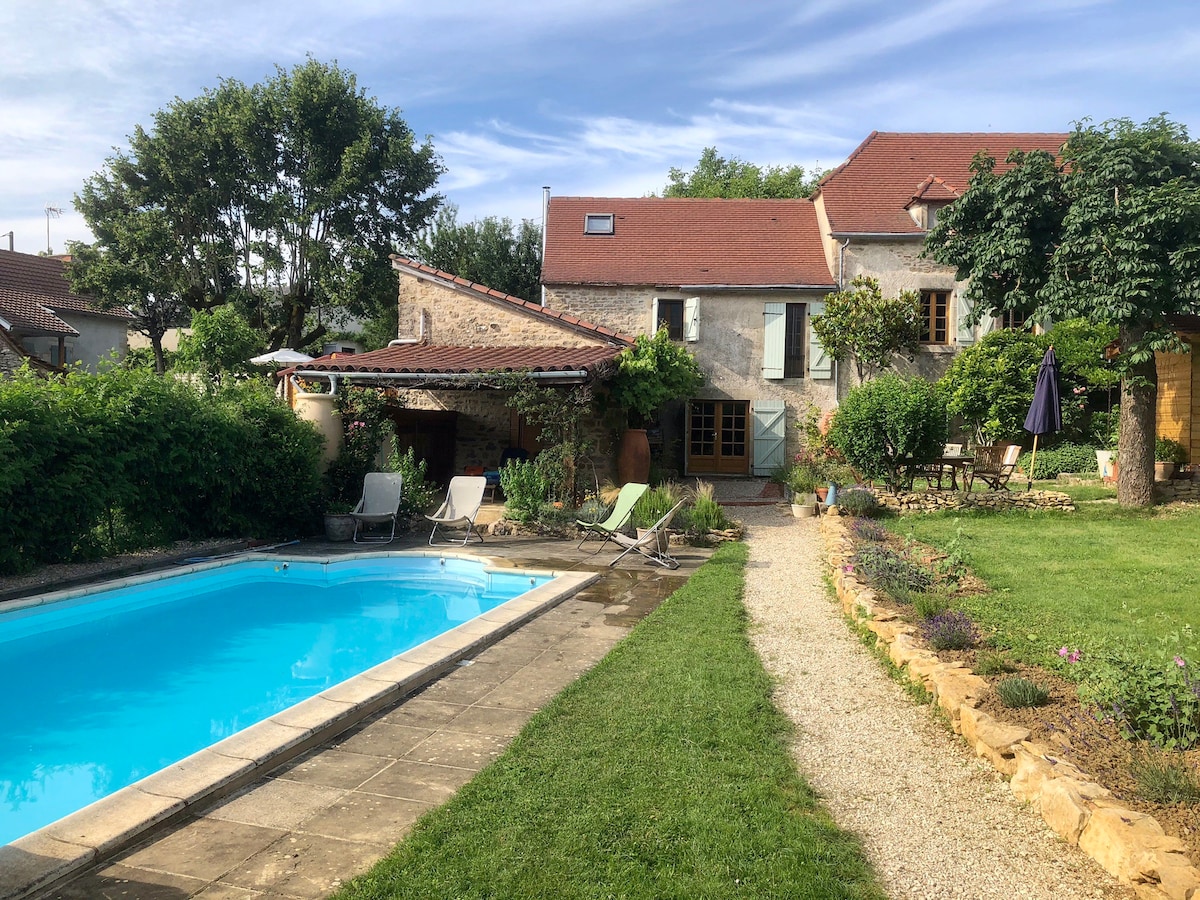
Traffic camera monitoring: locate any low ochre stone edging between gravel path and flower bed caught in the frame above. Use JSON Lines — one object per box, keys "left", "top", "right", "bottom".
{"left": 821, "top": 516, "right": 1200, "bottom": 900}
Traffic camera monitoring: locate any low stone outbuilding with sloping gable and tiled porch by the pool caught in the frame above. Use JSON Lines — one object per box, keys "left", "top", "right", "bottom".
{"left": 283, "top": 257, "right": 632, "bottom": 484}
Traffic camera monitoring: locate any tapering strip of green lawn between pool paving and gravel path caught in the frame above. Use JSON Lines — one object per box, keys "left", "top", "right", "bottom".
{"left": 336, "top": 544, "right": 883, "bottom": 900}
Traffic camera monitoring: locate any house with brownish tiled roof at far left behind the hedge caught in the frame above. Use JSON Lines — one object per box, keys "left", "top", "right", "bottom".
{"left": 0, "top": 251, "right": 132, "bottom": 372}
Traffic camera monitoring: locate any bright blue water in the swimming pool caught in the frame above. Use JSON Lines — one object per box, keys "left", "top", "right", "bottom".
{"left": 0, "top": 557, "right": 550, "bottom": 845}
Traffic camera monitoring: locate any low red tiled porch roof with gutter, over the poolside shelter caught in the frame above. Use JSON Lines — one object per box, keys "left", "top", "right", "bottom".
{"left": 296, "top": 343, "right": 623, "bottom": 374}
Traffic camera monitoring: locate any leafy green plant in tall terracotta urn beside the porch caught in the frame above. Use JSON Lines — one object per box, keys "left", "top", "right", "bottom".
{"left": 608, "top": 328, "right": 704, "bottom": 482}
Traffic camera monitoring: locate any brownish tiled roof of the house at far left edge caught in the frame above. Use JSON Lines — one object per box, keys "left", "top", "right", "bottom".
{"left": 0, "top": 251, "right": 132, "bottom": 335}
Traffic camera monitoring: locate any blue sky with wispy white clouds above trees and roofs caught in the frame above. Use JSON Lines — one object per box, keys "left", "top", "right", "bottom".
{"left": 0, "top": 0, "right": 1200, "bottom": 253}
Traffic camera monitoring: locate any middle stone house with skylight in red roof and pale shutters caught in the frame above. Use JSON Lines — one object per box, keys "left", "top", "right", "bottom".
{"left": 541, "top": 197, "right": 836, "bottom": 475}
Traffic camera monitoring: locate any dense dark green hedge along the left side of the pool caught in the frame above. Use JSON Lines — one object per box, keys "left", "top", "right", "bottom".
{"left": 0, "top": 370, "right": 322, "bottom": 574}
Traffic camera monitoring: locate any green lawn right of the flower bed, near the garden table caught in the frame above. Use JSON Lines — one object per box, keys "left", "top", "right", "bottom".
{"left": 889, "top": 508, "right": 1200, "bottom": 665}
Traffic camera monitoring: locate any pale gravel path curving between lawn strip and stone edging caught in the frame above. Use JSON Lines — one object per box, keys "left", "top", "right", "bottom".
{"left": 739, "top": 508, "right": 1133, "bottom": 900}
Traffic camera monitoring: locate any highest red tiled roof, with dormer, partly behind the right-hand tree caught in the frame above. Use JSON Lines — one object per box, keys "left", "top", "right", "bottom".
{"left": 817, "top": 131, "right": 1067, "bottom": 234}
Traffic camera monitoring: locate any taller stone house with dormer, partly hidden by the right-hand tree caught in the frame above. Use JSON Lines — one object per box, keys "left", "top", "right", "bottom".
{"left": 812, "top": 132, "right": 1067, "bottom": 378}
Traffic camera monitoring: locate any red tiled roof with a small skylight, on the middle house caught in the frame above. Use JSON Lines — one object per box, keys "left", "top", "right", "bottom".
{"left": 541, "top": 197, "right": 833, "bottom": 287}
